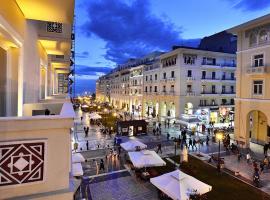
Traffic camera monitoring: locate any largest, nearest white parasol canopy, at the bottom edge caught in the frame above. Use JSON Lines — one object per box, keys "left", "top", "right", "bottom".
{"left": 150, "top": 170, "right": 212, "bottom": 200}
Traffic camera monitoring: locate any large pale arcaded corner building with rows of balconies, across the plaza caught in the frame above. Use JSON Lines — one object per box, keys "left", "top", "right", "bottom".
{"left": 97, "top": 32, "right": 236, "bottom": 126}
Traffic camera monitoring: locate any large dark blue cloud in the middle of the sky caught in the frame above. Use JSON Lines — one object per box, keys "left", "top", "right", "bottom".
{"left": 81, "top": 0, "right": 182, "bottom": 63}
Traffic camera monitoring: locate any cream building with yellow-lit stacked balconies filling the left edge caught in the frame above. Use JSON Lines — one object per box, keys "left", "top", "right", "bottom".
{"left": 0, "top": 0, "right": 74, "bottom": 199}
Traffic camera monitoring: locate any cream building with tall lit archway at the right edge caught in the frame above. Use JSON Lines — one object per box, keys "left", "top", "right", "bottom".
{"left": 229, "top": 15, "right": 270, "bottom": 149}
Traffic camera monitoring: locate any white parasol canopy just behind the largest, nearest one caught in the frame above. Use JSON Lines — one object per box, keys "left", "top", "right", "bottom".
{"left": 128, "top": 150, "right": 166, "bottom": 168}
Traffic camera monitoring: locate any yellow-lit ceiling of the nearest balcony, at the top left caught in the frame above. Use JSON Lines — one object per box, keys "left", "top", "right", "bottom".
{"left": 16, "top": 0, "right": 74, "bottom": 24}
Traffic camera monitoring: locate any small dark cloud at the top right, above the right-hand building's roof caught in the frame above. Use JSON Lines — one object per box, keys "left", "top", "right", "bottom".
{"left": 227, "top": 0, "right": 270, "bottom": 11}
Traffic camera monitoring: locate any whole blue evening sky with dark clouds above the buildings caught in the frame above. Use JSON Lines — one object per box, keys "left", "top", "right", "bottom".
{"left": 75, "top": 0, "right": 270, "bottom": 93}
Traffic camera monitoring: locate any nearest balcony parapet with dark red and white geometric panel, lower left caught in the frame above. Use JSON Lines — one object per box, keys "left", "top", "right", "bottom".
{"left": 0, "top": 103, "right": 75, "bottom": 199}
